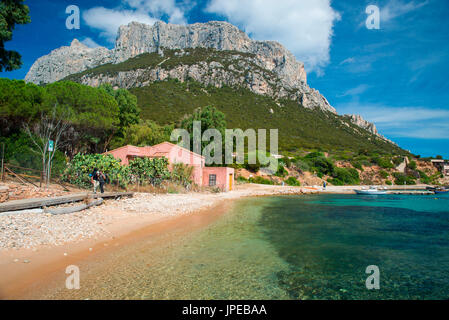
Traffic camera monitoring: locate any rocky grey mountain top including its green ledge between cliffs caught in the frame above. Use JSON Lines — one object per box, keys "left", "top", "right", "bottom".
{"left": 25, "top": 21, "right": 387, "bottom": 141}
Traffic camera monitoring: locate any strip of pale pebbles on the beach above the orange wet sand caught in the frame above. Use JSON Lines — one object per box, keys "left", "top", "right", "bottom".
{"left": 0, "top": 185, "right": 310, "bottom": 250}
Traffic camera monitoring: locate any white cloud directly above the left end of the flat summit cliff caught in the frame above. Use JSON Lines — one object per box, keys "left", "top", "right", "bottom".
{"left": 83, "top": 0, "right": 187, "bottom": 42}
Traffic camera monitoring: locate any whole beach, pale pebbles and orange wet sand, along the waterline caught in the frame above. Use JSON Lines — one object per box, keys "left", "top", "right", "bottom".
{"left": 0, "top": 185, "right": 322, "bottom": 299}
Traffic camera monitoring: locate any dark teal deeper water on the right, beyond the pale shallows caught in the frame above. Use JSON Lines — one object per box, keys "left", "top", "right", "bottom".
{"left": 260, "top": 195, "right": 449, "bottom": 299}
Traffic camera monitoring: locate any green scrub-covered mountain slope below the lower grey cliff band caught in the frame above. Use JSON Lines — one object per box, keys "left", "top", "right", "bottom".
{"left": 131, "top": 80, "right": 406, "bottom": 154}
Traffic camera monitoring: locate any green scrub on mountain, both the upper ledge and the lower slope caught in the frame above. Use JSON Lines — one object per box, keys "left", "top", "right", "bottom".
{"left": 61, "top": 48, "right": 407, "bottom": 155}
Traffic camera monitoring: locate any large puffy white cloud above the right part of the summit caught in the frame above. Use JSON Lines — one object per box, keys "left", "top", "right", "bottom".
{"left": 206, "top": 0, "right": 340, "bottom": 72}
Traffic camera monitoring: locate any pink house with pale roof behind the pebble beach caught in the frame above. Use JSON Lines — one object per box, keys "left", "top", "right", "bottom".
{"left": 105, "top": 142, "right": 234, "bottom": 191}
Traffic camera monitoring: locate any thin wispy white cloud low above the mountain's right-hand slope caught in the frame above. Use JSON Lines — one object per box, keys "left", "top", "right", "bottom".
{"left": 337, "top": 102, "right": 449, "bottom": 139}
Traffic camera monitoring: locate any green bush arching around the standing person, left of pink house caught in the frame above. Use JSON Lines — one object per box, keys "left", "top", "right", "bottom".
{"left": 62, "top": 153, "right": 131, "bottom": 188}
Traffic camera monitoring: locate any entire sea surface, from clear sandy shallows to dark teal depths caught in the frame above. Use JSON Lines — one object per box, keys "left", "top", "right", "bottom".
{"left": 48, "top": 195, "right": 449, "bottom": 299}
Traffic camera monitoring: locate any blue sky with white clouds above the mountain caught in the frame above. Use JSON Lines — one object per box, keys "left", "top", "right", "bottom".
{"left": 0, "top": 0, "right": 449, "bottom": 158}
